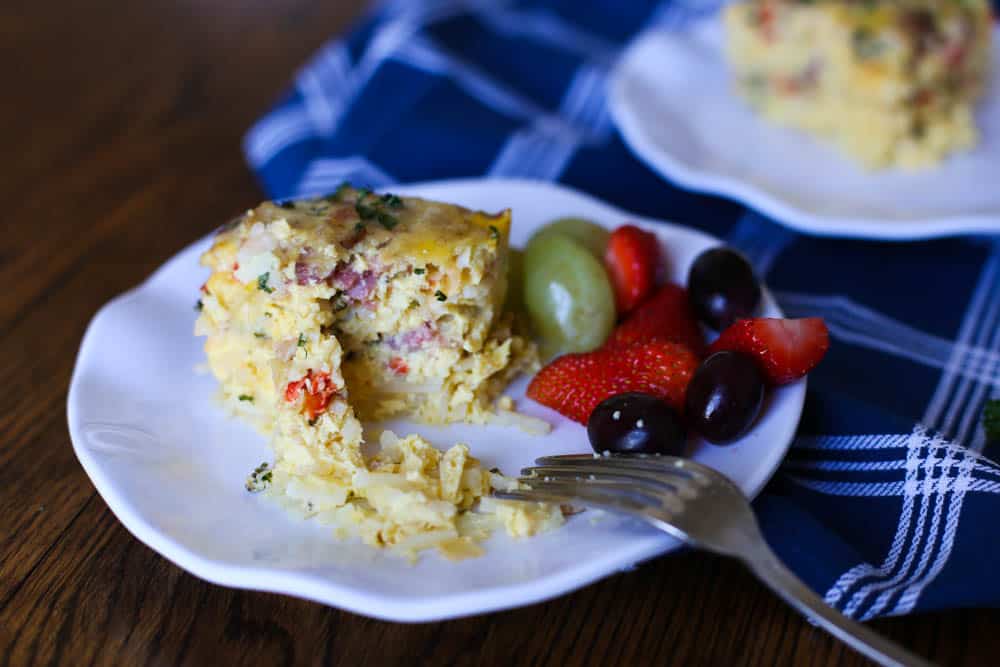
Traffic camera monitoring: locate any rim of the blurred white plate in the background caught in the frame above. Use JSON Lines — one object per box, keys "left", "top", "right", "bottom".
{"left": 609, "top": 23, "right": 1000, "bottom": 241}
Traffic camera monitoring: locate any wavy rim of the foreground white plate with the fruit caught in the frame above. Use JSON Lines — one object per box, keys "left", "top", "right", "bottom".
{"left": 66, "top": 178, "right": 807, "bottom": 623}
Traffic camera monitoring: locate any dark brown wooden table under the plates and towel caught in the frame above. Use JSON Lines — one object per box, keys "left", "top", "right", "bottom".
{"left": 0, "top": 0, "right": 1000, "bottom": 665}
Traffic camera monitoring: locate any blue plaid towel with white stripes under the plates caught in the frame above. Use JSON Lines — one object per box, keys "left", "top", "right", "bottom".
{"left": 245, "top": 0, "right": 1000, "bottom": 619}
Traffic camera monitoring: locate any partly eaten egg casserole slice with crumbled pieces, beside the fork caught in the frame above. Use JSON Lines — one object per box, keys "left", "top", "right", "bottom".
{"left": 195, "top": 186, "right": 562, "bottom": 558}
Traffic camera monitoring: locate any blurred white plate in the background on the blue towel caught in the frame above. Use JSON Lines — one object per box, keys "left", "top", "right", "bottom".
{"left": 611, "top": 16, "right": 1000, "bottom": 239}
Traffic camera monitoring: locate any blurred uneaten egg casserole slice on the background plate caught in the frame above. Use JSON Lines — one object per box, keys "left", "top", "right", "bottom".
{"left": 723, "top": 0, "right": 993, "bottom": 169}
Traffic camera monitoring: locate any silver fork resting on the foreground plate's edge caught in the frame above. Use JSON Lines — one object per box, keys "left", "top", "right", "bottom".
{"left": 493, "top": 454, "right": 931, "bottom": 665}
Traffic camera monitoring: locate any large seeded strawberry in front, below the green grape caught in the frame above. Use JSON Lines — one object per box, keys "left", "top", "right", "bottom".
{"left": 527, "top": 340, "right": 698, "bottom": 424}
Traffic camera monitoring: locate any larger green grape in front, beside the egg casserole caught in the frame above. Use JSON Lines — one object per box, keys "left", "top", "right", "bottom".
{"left": 524, "top": 234, "right": 615, "bottom": 352}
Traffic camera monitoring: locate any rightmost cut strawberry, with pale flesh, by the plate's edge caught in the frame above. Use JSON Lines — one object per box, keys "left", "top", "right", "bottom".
{"left": 709, "top": 317, "right": 830, "bottom": 385}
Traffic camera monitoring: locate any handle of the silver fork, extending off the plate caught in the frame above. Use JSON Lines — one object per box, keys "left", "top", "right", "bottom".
{"left": 741, "top": 544, "right": 932, "bottom": 667}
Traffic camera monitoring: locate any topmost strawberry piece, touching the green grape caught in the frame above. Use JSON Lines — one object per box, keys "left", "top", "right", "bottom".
{"left": 604, "top": 225, "right": 660, "bottom": 315}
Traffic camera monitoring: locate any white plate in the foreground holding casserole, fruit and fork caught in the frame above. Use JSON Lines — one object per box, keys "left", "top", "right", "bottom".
{"left": 68, "top": 180, "right": 805, "bottom": 621}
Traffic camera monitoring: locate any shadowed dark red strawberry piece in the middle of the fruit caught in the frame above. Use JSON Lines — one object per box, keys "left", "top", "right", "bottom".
{"left": 605, "top": 283, "right": 705, "bottom": 357}
